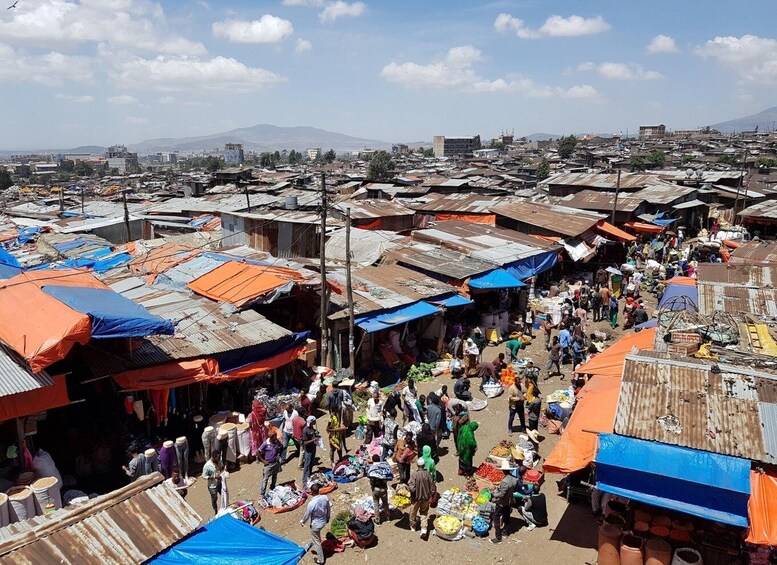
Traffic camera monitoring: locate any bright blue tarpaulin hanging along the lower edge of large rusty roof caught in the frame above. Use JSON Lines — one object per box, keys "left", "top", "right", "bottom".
{"left": 596, "top": 434, "right": 750, "bottom": 527}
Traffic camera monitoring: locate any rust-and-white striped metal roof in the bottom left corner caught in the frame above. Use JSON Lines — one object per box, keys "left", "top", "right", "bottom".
{"left": 0, "top": 473, "right": 201, "bottom": 565}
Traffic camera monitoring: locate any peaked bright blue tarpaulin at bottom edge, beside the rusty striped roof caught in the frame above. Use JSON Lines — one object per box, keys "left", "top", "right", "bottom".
{"left": 149, "top": 514, "right": 305, "bottom": 565}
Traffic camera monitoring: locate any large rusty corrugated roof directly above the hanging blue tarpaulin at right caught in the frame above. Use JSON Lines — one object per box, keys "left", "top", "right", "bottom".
{"left": 615, "top": 354, "right": 777, "bottom": 463}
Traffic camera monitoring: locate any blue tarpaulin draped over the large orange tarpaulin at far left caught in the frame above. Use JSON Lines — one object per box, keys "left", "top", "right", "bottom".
{"left": 43, "top": 285, "right": 175, "bottom": 339}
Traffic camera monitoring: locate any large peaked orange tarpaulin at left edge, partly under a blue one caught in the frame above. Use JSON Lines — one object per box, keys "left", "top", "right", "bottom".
{"left": 0, "top": 269, "right": 108, "bottom": 373}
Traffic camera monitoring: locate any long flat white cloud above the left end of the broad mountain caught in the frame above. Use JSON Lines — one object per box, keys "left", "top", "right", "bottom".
{"left": 110, "top": 56, "right": 286, "bottom": 92}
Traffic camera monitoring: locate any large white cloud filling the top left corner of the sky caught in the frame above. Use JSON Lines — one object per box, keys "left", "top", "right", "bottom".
{"left": 0, "top": 0, "right": 206, "bottom": 55}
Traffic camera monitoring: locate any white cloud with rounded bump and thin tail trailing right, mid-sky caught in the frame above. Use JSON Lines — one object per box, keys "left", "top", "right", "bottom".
{"left": 381, "top": 45, "right": 598, "bottom": 98}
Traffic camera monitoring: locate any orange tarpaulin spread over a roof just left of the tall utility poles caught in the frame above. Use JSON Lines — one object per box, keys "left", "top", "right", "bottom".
{"left": 187, "top": 261, "right": 300, "bottom": 307}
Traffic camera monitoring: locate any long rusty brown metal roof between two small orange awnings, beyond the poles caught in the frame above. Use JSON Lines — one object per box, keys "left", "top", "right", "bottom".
{"left": 491, "top": 200, "right": 607, "bottom": 237}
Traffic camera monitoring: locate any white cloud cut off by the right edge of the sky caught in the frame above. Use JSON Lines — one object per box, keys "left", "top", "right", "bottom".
{"left": 696, "top": 35, "right": 777, "bottom": 84}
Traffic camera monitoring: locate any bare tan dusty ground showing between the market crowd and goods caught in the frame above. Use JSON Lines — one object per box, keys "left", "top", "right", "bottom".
{"left": 187, "top": 302, "right": 655, "bottom": 564}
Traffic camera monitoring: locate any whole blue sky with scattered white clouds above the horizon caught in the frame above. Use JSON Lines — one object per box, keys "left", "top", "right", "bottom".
{"left": 0, "top": 0, "right": 777, "bottom": 149}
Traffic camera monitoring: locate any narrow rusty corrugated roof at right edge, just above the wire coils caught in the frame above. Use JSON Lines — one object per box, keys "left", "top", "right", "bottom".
{"left": 697, "top": 282, "right": 777, "bottom": 317}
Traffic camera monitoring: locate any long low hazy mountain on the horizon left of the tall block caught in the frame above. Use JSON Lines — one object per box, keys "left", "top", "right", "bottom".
{"left": 129, "top": 124, "right": 391, "bottom": 153}
